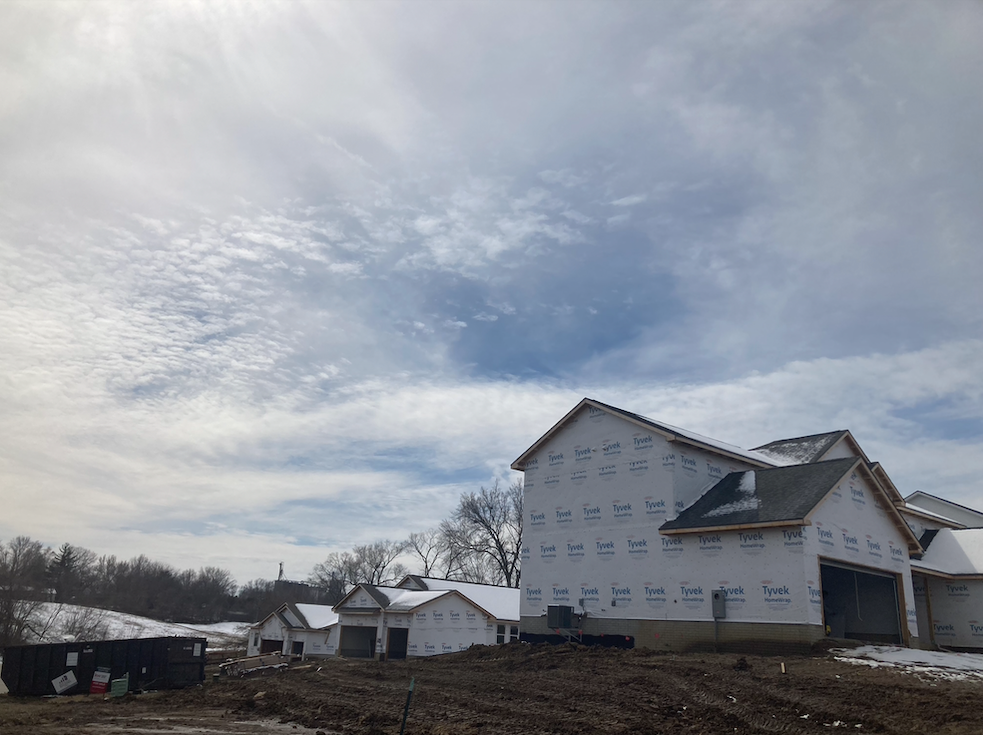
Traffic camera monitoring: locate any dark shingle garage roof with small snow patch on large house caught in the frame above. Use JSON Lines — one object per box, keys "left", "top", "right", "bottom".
{"left": 660, "top": 457, "right": 857, "bottom": 531}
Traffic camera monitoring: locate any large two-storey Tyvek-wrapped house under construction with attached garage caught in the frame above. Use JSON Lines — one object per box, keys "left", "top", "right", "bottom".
{"left": 512, "top": 399, "right": 983, "bottom": 650}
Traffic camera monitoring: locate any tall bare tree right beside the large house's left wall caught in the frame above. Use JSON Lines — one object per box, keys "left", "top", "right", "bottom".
{"left": 441, "top": 480, "right": 522, "bottom": 587}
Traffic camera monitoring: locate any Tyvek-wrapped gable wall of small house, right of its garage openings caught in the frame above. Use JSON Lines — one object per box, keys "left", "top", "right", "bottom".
{"left": 400, "top": 595, "right": 495, "bottom": 656}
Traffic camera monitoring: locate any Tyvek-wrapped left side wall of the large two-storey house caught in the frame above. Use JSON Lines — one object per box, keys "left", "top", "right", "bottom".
{"left": 522, "top": 407, "right": 910, "bottom": 636}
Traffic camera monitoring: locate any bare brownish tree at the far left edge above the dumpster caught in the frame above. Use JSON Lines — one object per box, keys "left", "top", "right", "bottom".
{"left": 0, "top": 536, "right": 51, "bottom": 648}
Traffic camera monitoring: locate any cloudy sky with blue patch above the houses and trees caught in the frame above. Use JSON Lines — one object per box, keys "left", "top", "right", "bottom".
{"left": 0, "top": 0, "right": 983, "bottom": 582}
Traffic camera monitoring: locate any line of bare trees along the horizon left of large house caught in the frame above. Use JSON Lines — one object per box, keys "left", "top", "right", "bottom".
{"left": 0, "top": 481, "right": 522, "bottom": 649}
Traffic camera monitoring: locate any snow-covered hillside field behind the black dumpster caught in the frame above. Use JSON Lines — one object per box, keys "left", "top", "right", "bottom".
{"left": 26, "top": 602, "right": 249, "bottom": 649}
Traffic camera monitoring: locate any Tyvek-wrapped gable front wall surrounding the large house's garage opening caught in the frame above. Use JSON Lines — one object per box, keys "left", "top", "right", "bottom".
{"left": 807, "top": 473, "right": 919, "bottom": 646}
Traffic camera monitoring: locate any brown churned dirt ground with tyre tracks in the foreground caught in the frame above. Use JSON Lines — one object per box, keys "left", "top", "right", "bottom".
{"left": 0, "top": 644, "right": 983, "bottom": 735}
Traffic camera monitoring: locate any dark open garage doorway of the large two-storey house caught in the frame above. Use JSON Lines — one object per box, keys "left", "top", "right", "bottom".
{"left": 820, "top": 562, "right": 904, "bottom": 645}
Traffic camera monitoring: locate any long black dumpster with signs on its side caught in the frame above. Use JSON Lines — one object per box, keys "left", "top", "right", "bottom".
{"left": 0, "top": 638, "right": 207, "bottom": 696}
